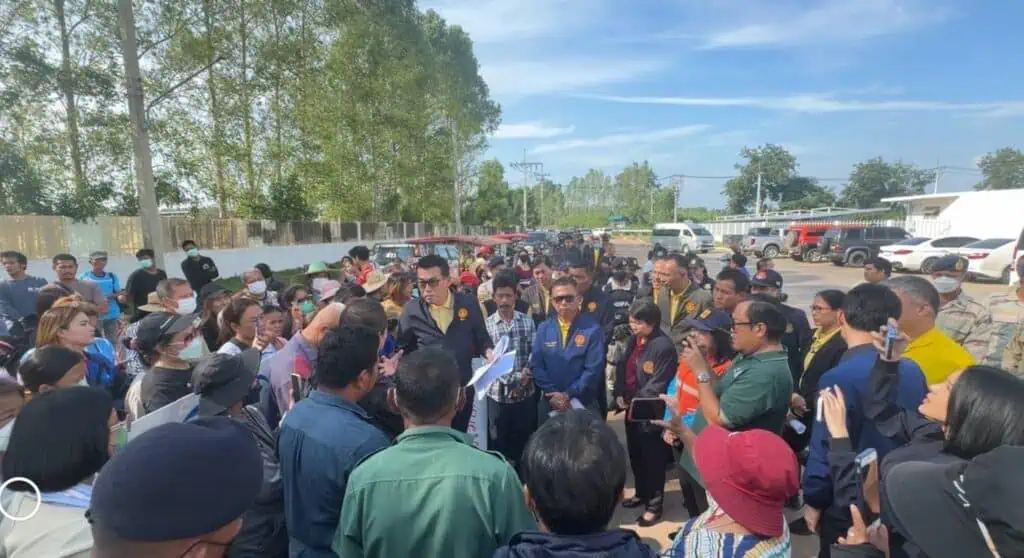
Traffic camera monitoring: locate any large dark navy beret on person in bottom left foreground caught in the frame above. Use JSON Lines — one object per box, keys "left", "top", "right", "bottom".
{"left": 86, "top": 417, "right": 263, "bottom": 542}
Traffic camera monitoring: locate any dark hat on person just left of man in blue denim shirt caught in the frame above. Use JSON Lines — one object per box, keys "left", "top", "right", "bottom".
{"left": 193, "top": 349, "right": 260, "bottom": 417}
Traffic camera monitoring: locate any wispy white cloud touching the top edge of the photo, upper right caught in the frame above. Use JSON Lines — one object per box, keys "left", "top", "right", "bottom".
{"left": 700, "top": 0, "right": 950, "bottom": 49}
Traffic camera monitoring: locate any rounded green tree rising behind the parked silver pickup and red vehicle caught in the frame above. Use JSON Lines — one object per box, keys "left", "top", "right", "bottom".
{"left": 722, "top": 143, "right": 797, "bottom": 213}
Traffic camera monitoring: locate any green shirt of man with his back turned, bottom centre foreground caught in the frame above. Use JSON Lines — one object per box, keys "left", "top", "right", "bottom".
{"left": 333, "top": 426, "right": 537, "bottom": 558}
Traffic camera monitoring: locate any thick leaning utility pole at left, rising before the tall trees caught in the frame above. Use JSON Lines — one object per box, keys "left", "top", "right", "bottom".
{"left": 118, "top": 0, "right": 165, "bottom": 267}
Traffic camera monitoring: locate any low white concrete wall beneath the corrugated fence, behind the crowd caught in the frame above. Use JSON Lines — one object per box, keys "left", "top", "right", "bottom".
{"left": 29, "top": 242, "right": 385, "bottom": 287}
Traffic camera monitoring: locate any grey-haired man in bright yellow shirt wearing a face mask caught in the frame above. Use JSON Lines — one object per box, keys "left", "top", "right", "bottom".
{"left": 885, "top": 275, "right": 974, "bottom": 385}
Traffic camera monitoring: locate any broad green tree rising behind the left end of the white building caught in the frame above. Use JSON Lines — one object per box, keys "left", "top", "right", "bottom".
{"left": 842, "top": 157, "right": 935, "bottom": 209}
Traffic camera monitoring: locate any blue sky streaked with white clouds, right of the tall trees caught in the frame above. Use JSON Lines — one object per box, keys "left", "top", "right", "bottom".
{"left": 421, "top": 0, "right": 1024, "bottom": 207}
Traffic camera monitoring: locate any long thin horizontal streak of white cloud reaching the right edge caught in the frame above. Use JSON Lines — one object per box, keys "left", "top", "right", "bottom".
{"left": 578, "top": 94, "right": 1024, "bottom": 116}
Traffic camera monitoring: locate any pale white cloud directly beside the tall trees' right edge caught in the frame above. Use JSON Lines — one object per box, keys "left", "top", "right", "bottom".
{"left": 480, "top": 57, "right": 666, "bottom": 98}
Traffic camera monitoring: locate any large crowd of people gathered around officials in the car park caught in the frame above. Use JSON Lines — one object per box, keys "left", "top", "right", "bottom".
{"left": 0, "top": 232, "right": 1024, "bottom": 558}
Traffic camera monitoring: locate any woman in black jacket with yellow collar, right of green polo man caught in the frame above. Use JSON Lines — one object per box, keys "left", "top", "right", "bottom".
{"left": 782, "top": 289, "right": 846, "bottom": 456}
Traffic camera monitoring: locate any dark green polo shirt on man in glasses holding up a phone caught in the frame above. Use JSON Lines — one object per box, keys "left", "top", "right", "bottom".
{"left": 679, "top": 350, "right": 793, "bottom": 482}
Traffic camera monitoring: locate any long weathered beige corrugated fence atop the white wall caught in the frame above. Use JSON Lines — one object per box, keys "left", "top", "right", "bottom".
{"left": 0, "top": 215, "right": 516, "bottom": 259}
